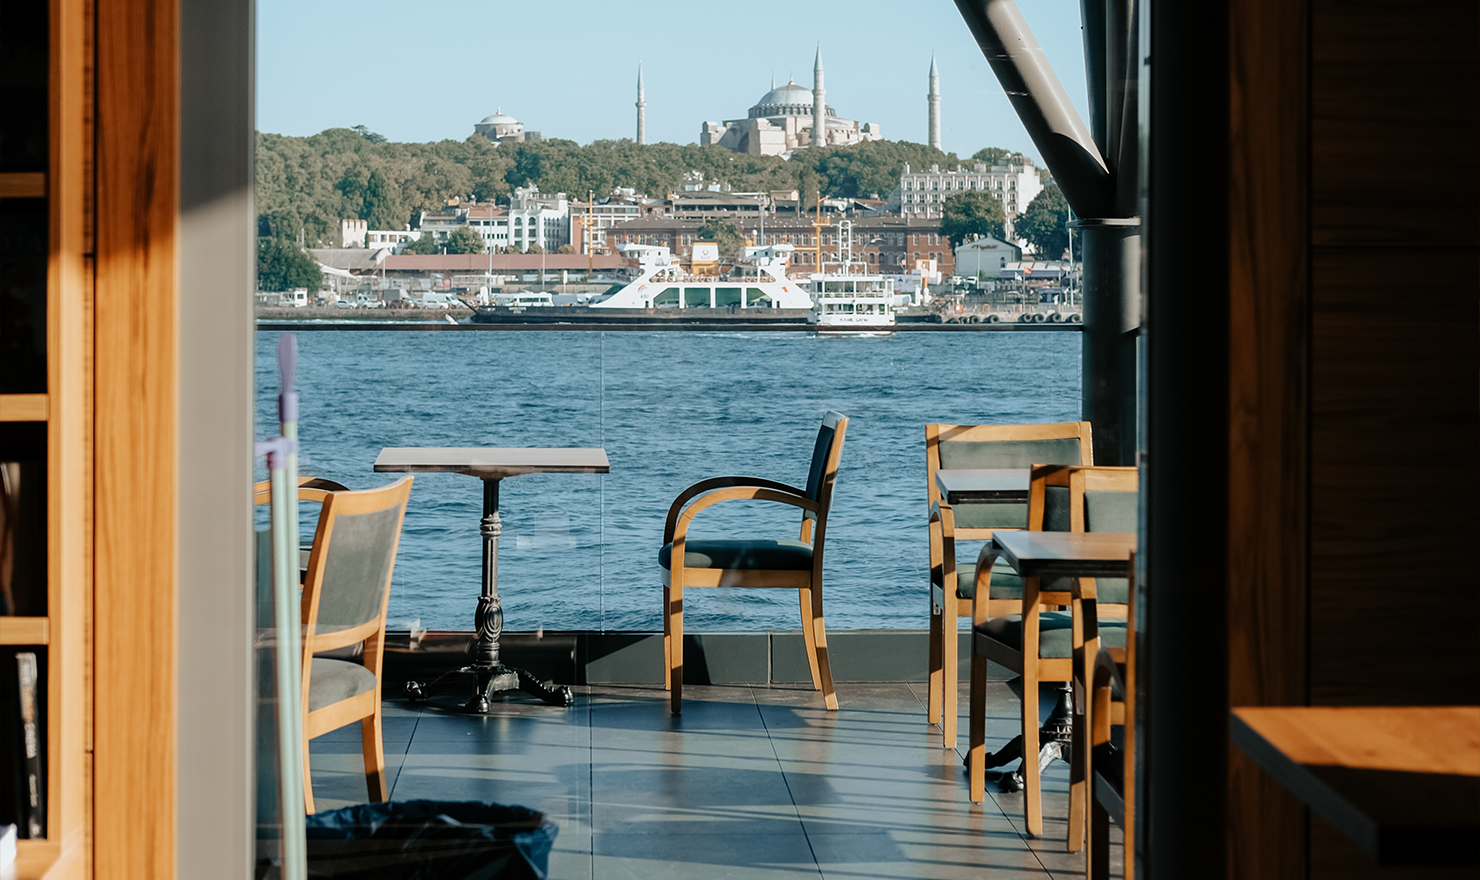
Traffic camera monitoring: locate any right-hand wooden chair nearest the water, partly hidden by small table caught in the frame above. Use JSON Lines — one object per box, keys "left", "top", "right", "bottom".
{"left": 925, "top": 422, "right": 1094, "bottom": 748}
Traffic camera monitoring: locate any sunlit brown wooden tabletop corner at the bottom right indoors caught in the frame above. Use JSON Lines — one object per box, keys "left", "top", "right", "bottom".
{"left": 1228, "top": 705, "right": 1480, "bottom": 865}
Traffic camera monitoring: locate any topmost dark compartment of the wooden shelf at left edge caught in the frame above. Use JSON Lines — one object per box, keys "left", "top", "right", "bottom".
{"left": 0, "top": 0, "right": 50, "bottom": 173}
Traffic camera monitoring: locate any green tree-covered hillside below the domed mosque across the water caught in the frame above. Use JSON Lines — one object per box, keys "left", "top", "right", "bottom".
{"left": 256, "top": 126, "right": 1030, "bottom": 247}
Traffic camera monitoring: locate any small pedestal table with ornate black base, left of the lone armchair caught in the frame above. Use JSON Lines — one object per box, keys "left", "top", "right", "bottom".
{"left": 374, "top": 447, "right": 611, "bottom": 713}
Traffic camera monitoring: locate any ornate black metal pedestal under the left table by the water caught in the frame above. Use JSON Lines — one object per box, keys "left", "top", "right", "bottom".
{"left": 406, "top": 478, "right": 576, "bottom": 713}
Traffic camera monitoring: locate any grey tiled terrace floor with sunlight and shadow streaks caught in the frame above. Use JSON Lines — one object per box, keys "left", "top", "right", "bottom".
{"left": 311, "top": 682, "right": 1118, "bottom": 880}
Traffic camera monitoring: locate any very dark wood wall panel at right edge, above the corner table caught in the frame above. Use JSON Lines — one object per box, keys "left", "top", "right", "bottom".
{"left": 1310, "top": 0, "right": 1480, "bottom": 704}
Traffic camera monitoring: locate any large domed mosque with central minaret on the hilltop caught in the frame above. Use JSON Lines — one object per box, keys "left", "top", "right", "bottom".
{"left": 699, "top": 47, "right": 882, "bottom": 155}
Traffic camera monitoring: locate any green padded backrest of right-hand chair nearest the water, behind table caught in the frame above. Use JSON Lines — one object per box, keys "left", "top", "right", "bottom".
{"left": 925, "top": 422, "right": 1094, "bottom": 529}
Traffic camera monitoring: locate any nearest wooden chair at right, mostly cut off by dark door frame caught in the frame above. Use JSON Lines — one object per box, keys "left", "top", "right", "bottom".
{"left": 1083, "top": 553, "right": 1135, "bottom": 880}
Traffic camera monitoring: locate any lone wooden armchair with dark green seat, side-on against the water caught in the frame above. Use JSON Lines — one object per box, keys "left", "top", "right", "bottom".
{"left": 659, "top": 413, "right": 848, "bottom": 714}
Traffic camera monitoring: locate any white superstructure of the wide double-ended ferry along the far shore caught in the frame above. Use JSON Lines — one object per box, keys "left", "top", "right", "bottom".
{"left": 591, "top": 244, "right": 813, "bottom": 312}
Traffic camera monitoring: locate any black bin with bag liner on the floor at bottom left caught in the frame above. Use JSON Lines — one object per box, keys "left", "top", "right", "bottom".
{"left": 258, "top": 800, "right": 558, "bottom": 880}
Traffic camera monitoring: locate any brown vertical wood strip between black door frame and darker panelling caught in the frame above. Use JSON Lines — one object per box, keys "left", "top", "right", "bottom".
{"left": 1225, "top": 0, "right": 1310, "bottom": 880}
